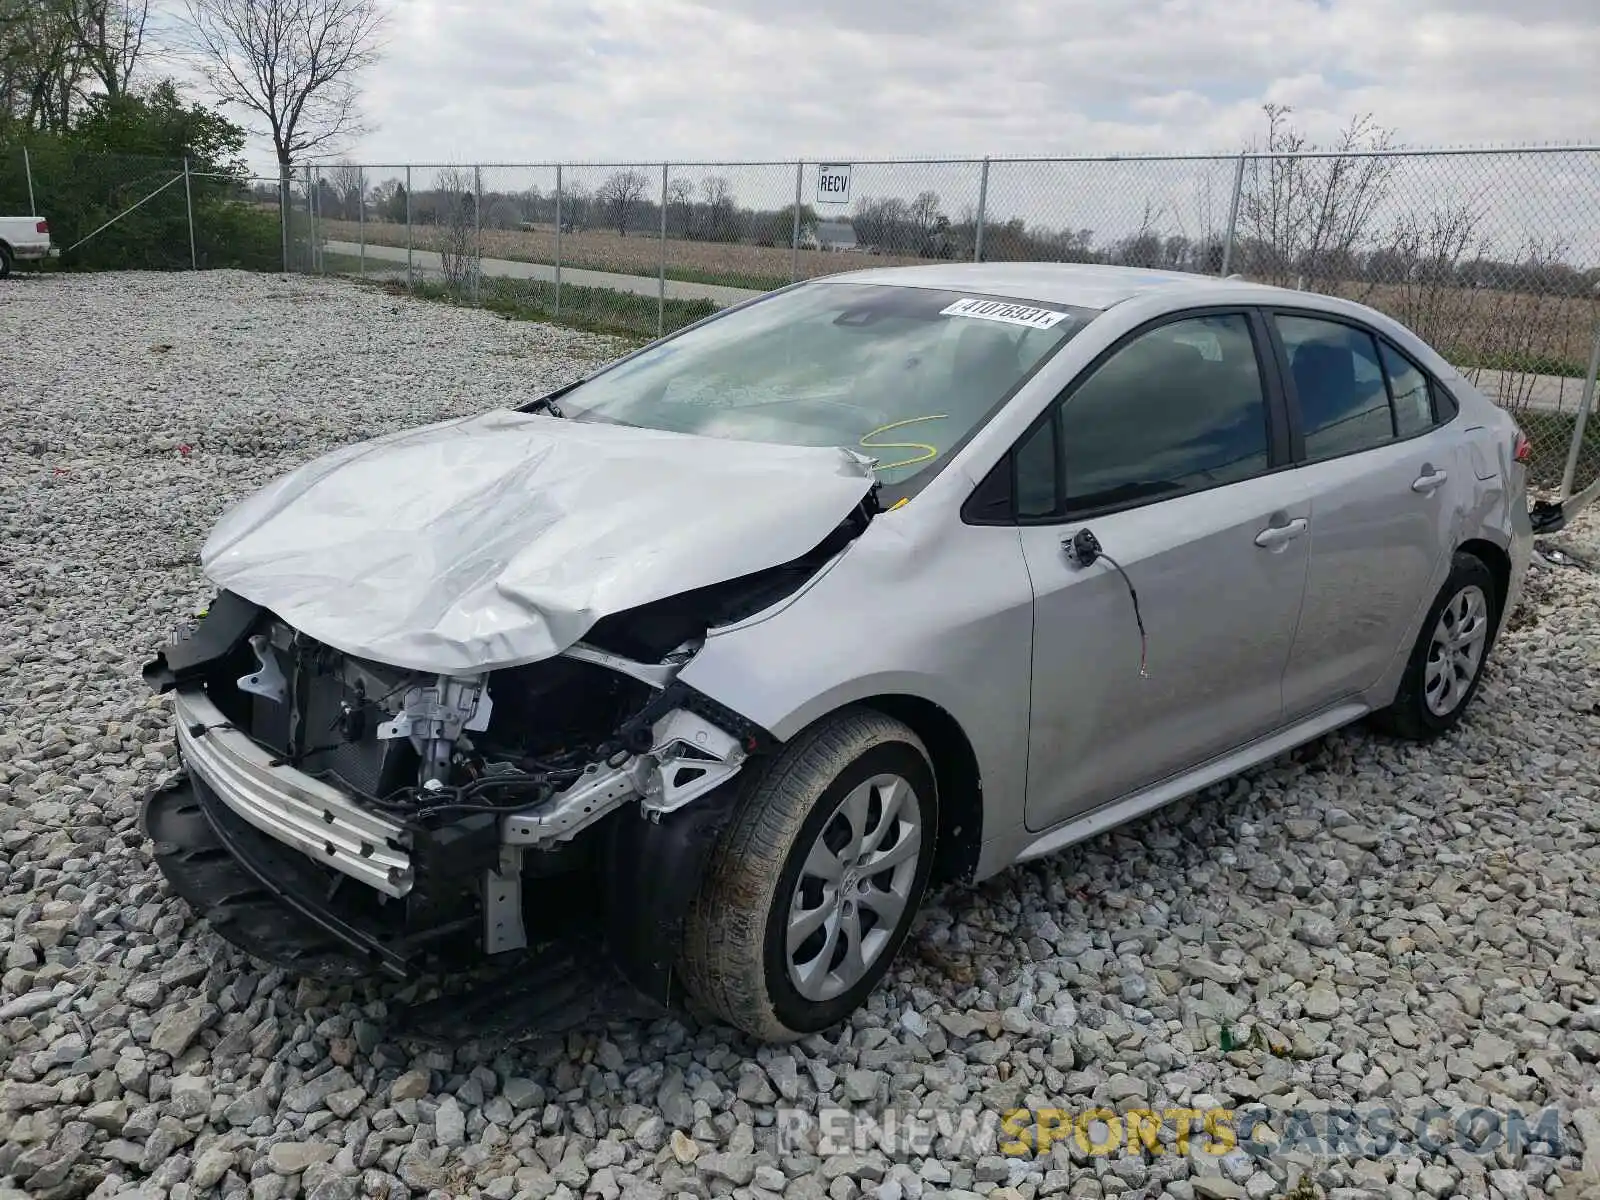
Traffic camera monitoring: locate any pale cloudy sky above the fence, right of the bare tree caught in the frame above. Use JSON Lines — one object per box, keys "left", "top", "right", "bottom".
{"left": 300, "top": 0, "right": 1600, "bottom": 169}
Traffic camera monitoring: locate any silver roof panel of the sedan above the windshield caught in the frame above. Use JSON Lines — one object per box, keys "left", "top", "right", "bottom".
{"left": 813, "top": 262, "right": 1307, "bottom": 309}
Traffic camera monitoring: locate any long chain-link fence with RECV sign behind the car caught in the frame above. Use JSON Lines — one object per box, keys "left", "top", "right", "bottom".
{"left": 0, "top": 147, "right": 1600, "bottom": 496}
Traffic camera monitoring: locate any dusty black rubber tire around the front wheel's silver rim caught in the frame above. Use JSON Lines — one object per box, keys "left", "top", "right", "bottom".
{"left": 680, "top": 709, "right": 938, "bottom": 1042}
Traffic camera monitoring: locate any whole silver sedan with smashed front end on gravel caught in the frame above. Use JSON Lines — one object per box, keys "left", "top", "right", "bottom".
{"left": 147, "top": 264, "right": 1531, "bottom": 1040}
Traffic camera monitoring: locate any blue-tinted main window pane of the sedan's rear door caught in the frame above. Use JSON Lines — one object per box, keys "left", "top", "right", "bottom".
{"left": 1275, "top": 315, "right": 1395, "bottom": 462}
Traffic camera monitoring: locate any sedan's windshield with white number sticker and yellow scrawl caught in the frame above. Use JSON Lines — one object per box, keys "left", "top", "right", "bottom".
{"left": 560, "top": 282, "right": 1094, "bottom": 485}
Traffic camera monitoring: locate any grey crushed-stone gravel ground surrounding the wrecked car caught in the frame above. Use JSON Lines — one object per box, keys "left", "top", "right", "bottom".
{"left": 0, "top": 272, "right": 1600, "bottom": 1200}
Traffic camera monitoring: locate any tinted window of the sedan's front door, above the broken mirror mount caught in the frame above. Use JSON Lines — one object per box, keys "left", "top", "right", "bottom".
{"left": 1019, "top": 314, "right": 1267, "bottom": 515}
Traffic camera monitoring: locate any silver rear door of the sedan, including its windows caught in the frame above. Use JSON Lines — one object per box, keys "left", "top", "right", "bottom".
{"left": 1269, "top": 309, "right": 1475, "bottom": 720}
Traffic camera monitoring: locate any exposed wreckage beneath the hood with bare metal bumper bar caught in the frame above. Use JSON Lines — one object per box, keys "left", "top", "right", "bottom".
{"left": 144, "top": 563, "right": 825, "bottom": 1002}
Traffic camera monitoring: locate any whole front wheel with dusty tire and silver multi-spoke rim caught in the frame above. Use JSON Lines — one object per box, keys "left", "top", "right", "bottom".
{"left": 682, "top": 709, "right": 938, "bottom": 1042}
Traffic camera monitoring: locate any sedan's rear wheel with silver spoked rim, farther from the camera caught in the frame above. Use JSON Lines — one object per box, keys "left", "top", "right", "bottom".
{"left": 1378, "top": 552, "right": 1499, "bottom": 741}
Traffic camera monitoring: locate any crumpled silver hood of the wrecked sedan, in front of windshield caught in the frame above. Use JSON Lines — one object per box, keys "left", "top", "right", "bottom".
{"left": 200, "top": 410, "right": 872, "bottom": 674}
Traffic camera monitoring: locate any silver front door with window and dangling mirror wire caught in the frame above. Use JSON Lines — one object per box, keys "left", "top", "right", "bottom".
{"left": 1014, "top": 310, "right": 1309, "bottom": 829}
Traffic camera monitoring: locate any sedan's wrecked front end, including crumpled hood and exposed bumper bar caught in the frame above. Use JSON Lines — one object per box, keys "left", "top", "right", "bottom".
{"left": 144, "top": 410, "right": 878, "bottom": 1036}
